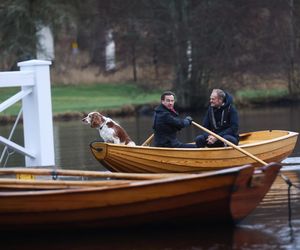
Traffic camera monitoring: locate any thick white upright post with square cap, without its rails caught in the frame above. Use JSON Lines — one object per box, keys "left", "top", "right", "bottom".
{"left": 18, "top": 60, "right": 55, "bottom": 167}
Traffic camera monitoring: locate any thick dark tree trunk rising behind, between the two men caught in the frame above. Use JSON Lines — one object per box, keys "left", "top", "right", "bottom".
{"left": 172, "top": 0, "right": 209, "bottom": 110}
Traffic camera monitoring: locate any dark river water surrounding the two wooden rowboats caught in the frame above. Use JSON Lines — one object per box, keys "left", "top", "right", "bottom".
{"left": 0, "top": 106, "right": 300, "bottom": 250}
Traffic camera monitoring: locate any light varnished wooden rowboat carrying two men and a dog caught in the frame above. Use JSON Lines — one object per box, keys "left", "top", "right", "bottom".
{"left": 90, "top": 130, "right": 298, "bottom": 173}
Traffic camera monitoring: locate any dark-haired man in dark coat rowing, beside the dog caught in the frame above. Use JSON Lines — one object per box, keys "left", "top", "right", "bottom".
{"left": 153, "top": 91, "right": 196, "bottom": 148}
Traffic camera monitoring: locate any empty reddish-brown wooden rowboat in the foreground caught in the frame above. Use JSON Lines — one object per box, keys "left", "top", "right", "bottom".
{"left": 0, "top": 163, "right": 281, "bottom": 230}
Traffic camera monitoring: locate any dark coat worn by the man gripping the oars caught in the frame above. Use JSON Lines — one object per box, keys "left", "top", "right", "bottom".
{"left": 153, "top": 104, "right": 190, "bottom": 148}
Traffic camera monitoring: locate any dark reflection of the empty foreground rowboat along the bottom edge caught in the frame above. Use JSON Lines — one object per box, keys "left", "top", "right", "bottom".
{"left": 1, "top": 225, "right": 279, "bottom": 250}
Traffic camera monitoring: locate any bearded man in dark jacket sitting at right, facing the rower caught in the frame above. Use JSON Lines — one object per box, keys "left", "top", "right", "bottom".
{"left": 196, "top": 89, "right": 239, "bottom": 147}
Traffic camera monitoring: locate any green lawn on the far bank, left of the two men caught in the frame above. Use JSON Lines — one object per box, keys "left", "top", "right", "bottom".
{"left": 0, "top": 83, "right": 161, "bottom": 115}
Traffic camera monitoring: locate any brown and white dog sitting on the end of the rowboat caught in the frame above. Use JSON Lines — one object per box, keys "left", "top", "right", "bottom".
{"left": 82, "top": 112, "right": 135, "bottom": 146}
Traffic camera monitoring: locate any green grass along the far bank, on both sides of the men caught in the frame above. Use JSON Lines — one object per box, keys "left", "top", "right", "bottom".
{"left": 0, "top": 83, "right": 288, "bottom": 119}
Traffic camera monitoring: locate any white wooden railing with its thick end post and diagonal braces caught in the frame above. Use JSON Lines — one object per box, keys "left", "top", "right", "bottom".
{"left": 0, "top": 60, "right": 55, "bottom": 167}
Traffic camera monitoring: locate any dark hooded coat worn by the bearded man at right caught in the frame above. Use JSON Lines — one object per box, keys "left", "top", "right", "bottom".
{"left": 203, "top": 93, "right": 239, "bottom": 139}
